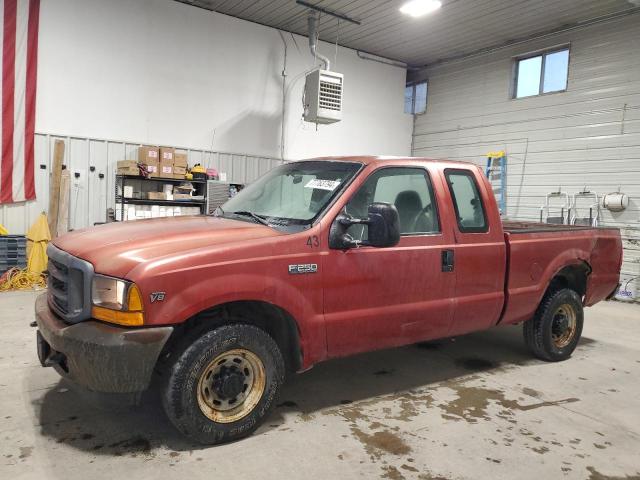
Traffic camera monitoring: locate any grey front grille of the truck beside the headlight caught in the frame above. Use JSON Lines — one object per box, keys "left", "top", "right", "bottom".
{"left": 47, "top": 244, "right": 93, "bottom": 323}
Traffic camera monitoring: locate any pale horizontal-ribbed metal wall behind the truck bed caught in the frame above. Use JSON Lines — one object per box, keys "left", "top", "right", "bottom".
{"left": 413, "top": 14, "right": 640, "bottom": 300}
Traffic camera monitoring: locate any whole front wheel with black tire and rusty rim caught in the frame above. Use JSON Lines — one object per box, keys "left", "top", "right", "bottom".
{"left": 162, "top": 324, "right": 285, "bottom": 445}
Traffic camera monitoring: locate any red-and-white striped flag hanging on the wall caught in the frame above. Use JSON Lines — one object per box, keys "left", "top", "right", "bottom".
{"left": 0, "top": 0, "right": 40, "bottom": 204}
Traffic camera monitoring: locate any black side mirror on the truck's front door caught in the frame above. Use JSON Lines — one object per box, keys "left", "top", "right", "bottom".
{"left": 329, "top": 202, "right": 400, "bottom": 250}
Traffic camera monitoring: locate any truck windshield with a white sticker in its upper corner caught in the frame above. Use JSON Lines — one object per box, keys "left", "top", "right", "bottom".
{"left": 216, "top": 160, "right": 362, "bottom": 231}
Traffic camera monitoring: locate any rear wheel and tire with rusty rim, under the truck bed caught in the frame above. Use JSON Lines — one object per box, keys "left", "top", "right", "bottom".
{"left": 523, "top": 288, "right": 584, "bottom": 362}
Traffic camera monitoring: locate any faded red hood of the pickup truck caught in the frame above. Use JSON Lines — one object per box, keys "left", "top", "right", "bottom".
{"left": 53, "top": 216, "right": 283, "bottom": 277}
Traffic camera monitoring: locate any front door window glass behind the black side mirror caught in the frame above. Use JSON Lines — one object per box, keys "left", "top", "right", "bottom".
{"left": 346, "top": 167, "right": 440, "bottom": 240}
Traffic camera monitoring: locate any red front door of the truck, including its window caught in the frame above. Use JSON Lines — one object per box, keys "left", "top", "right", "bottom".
{"left": 322, "top": 165, "right": 455, "bottom": 357}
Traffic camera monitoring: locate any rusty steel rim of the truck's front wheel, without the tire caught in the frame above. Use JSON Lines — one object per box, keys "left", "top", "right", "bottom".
{"left": 198, "top": 348, "right": 266, "bottom": 423}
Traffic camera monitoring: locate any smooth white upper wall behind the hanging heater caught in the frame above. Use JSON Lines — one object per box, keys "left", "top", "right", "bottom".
{"left": 36, "top": 0, "right": 412, "bottom": 160}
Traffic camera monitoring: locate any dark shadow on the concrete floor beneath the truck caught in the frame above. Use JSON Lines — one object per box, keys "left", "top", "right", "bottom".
{"left": 32, "top": 327, "right": 594, "bottom": 457}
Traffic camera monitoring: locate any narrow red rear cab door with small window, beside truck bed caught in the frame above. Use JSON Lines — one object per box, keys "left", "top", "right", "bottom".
{"left": 443, "top": 166, "right": 506, "bottom": 335}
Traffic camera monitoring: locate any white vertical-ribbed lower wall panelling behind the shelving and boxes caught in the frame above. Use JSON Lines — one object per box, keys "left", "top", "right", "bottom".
{"left": 0, "top": 133, "right": 282, "bottom": 234}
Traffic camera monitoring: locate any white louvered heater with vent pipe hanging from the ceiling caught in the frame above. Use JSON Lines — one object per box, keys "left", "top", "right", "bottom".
{"left": 302, "top": 11, "right": 344, "bottom": 124}
